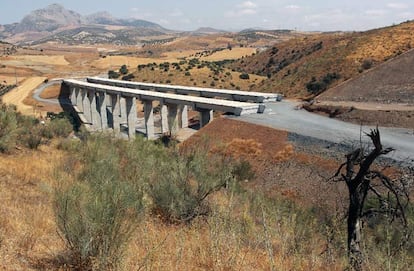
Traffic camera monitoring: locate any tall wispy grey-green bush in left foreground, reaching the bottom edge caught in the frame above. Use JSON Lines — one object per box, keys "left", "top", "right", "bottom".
{"left": 55, "top": 137, "right": 142, "bottom": 270}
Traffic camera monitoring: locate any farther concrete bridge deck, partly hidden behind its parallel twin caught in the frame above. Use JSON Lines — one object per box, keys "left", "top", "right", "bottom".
{"left": 87, "top": 77, "right": 282, "bottom": 103}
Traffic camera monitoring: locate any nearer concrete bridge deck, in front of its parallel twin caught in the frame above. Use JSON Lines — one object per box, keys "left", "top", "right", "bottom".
{"left": 63, "top": 79, "right": 265, "bottom": 116}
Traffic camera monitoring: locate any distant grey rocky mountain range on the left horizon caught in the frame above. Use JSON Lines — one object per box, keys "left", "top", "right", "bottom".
{"left": 0, "top": 4, "right": 171, "bottom": 44}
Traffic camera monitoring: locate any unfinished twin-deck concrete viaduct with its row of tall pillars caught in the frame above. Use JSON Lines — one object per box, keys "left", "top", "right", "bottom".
{"left": 63, "top": 77, "right": 281, "bottom": 139}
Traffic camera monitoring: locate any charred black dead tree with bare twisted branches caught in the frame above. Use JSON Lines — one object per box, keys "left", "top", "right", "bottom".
{"left": 334, "top": 127, "right": 409, "bottom": 270}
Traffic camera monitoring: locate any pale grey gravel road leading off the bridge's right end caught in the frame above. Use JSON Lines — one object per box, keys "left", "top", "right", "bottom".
{"left": 236, "top": 100, "right": 414, "bottom": 164}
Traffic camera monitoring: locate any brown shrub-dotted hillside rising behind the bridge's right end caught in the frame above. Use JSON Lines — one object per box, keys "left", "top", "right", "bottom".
{"left": 232, "top": 21, "right": 414, "bottom": 98}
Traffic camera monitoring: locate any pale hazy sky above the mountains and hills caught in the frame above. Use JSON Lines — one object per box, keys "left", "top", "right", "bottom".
{"left": 0, "top": 0, "right": 414, "bottom": 31}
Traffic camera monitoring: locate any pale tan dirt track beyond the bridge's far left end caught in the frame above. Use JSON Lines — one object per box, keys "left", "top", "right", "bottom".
{"left": 2, "top": 77, "right": 46, "bottom": 115}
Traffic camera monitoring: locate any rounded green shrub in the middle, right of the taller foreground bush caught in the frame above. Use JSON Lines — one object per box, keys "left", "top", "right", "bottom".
{"left": 150, "top": 152, "right": 233, "bottom": 223}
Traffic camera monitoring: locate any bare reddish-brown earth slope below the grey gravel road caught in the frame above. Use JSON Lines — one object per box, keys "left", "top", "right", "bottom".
{"left": 182, "top": 118, "right": 346, "bottom": 210}
